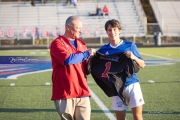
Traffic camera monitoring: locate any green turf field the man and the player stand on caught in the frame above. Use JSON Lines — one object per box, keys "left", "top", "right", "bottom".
{"left": 0, "top": 47, "right": 180, "bottom": 120}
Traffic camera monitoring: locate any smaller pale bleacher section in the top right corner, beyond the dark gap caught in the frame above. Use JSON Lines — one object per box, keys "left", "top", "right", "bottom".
{"left": 150, "top": 0, "right": 180, "bottom": 36}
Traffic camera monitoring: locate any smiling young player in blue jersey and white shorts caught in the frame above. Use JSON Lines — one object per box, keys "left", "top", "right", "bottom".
{"left": 98, "top": 19, "right": 145, "bottom": 120}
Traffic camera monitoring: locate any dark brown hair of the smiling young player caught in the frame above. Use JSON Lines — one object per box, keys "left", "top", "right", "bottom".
{"left": 104, "top": 19, "right": 121, "bottom": 31}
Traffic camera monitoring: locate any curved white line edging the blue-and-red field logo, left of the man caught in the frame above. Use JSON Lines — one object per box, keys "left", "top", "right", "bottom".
{"left": 0, "top": 69, "right": 52, "bottom": 79}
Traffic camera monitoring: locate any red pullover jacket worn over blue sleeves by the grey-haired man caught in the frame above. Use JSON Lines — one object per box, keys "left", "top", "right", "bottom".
{"left": 50, "top": 36, "right": 90, "bottom": 100}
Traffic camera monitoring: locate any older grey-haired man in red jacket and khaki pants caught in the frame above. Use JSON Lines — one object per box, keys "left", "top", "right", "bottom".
{"left": 50, "top": 16, "right": 95, "bottom": 120}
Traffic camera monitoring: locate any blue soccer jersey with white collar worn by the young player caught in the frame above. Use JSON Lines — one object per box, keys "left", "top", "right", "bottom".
{"left": 98, "top": 40, "right": 142, "bottom": 87}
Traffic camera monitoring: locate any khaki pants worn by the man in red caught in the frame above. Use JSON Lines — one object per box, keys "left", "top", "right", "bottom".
{"left": 54, "top": 97, "right": 91, "bottom": 120}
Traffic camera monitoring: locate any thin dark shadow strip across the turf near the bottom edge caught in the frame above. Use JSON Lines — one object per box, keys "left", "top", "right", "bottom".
{"left": 0, "top": 108, "right": 180, "bottom": 114}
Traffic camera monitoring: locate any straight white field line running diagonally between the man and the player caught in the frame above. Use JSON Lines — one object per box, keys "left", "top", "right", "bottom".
{"left": 89, "top": 88, "right": 116, "bottom": 120}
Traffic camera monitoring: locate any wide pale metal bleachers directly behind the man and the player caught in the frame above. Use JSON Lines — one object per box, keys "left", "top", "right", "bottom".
{"left": 0, "top": 0, "right": 146, "bottom": 39}
